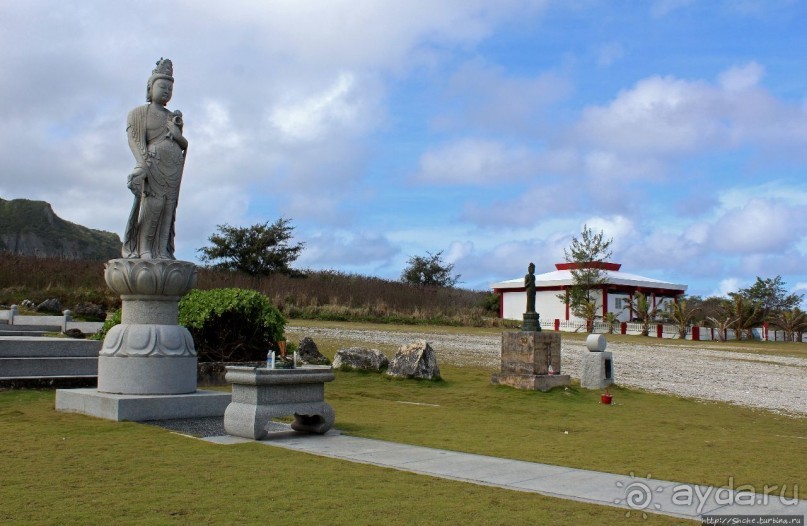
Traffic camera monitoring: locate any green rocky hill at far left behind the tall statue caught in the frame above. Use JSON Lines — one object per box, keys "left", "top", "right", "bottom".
{"left": 0, "top": 199, "right": 122, "bottom": 261}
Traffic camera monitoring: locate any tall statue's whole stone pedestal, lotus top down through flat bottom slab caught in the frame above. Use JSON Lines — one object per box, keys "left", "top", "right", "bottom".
{"left": 56, "top": 259, "right": 224, "bottom": 421}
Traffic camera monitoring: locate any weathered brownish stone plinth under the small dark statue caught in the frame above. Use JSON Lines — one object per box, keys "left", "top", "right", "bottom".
{"left": 490, "top": 331, "right": 571, "bottom": 391}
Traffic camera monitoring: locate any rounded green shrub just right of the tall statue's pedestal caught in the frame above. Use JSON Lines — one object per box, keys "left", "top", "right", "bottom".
{"left": 179, "top": 289, "right": 286, "bottom": 362}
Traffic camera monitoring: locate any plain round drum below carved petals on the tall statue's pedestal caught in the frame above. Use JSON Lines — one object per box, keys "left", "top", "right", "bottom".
{"left": 98, "top": 356, "right": 196, "bottom": 395}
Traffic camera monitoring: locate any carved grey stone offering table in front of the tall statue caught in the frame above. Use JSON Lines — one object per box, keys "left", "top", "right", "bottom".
{"left": 224, "top": 366, "right": 334, "bottom": 440}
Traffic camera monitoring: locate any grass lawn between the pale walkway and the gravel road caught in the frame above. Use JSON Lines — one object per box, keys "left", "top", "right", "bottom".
{"left": 288, "top": 324, "right": 807, "bottom": 496}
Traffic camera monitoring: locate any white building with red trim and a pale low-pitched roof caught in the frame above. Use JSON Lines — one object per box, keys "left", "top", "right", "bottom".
{"left": 491, "top": 262, "right": 687, "bottom": 323}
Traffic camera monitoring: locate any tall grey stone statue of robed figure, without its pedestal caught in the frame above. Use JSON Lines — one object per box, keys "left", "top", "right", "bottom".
{"left": 121, "top": 58, "right": 188, "bottom": 259}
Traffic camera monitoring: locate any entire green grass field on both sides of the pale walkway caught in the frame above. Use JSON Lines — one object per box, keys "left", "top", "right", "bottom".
{"left": 0, "top": 322, "right": 807, "bottom": 524}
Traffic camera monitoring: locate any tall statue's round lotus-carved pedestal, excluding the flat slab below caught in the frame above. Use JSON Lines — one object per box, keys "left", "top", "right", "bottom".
{"left": 98, "top": 259, "right": 197, "bottom": 395}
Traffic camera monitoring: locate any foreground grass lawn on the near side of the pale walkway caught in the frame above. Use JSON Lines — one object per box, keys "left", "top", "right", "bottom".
{"left": 0, "top": 390, "right": 696, "bottom": 525}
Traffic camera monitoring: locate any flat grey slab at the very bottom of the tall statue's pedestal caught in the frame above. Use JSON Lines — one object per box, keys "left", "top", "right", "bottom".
{"left": 56, "top": 389, "right": 231, "bottom": 422}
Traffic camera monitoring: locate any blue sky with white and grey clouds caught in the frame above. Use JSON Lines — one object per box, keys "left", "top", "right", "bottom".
{"left": 0, "top": 0, "right": 807, "bottom": 302}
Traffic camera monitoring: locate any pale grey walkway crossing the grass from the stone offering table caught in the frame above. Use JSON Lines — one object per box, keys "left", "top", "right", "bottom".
{"left": 203, "top": 432, "right": 807, "bottom": 524}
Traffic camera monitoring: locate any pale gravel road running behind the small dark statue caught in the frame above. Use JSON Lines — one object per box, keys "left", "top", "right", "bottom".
{"left": 286, "top": 327, "right": 807, "bottom": 416}
